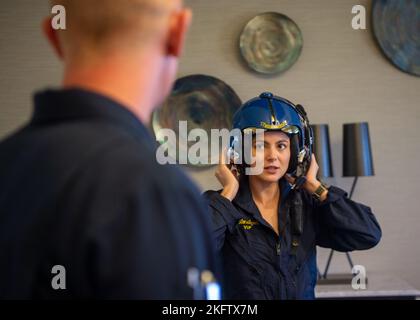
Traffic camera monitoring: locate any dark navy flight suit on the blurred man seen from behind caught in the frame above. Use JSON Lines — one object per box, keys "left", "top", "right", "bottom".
{"left": 0, "top": 89, "right": 217, "bottom": 299}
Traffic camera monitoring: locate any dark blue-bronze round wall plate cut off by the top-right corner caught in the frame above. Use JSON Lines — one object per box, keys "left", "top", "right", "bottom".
{"left": 372, "top": 0, "right": 420, "bottom": 76}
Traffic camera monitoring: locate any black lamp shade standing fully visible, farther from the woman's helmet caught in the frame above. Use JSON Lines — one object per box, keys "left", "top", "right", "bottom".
{"left": 343, "top": 122, "right": 375, "bottom": 177}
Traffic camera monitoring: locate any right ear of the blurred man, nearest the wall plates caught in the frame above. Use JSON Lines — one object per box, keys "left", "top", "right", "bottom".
{"left": 167, "top": 8, "right": 192, "bottom": 57}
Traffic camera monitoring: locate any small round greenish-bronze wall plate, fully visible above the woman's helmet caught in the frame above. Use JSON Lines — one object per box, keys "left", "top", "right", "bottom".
{"left": 240, "top": 12, "right": 303, "bottom": 74}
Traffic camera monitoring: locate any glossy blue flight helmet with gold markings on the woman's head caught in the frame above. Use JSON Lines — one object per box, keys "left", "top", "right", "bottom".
{"left": 231, "top": 92, "right": 313, "bottom": 177}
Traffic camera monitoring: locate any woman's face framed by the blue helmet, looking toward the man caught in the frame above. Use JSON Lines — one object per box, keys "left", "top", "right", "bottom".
{"left": 253, "top": 131, "right": 290, "bottom": 182}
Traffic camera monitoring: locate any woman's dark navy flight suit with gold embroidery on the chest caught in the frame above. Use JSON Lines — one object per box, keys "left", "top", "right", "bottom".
{"left": 204, "top": 179, "right": 381, "bottom": 300}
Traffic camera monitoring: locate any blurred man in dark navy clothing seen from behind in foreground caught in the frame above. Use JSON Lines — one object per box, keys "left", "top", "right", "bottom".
{"left": 0, "top": 0, "right": 215, "bottom": 299}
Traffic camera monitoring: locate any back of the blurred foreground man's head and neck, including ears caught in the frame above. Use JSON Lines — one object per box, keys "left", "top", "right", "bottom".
{"left": 44, "top": 0, "right": 192, "bottom": 121}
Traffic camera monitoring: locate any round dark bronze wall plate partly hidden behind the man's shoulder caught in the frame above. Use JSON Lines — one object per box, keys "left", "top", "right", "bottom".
{"left": 152, "top": 75, "right": 242, "bottom": 167}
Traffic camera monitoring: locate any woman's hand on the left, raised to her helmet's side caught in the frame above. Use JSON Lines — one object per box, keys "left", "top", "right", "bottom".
{"left": 215, "top": 150, "right": 239, "bottom": 201}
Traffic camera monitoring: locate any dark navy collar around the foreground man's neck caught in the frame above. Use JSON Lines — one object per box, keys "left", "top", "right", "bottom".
{"left": 30, "top": 88, "right": 156, "bottom": 148}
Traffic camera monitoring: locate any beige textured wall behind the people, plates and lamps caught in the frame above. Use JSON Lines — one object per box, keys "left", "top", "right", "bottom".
{"left": 0, "top": 0, "right": 420, "bottom": 289}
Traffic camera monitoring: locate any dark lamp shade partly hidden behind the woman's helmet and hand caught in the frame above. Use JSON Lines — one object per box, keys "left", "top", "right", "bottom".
{"left": 311, "top": 124, "right": 334, "bottom": 178}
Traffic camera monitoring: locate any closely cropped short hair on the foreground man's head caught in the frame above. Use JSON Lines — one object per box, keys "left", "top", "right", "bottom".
{"left": 50, "top": 0, "right": 180, "bottom": 48}
